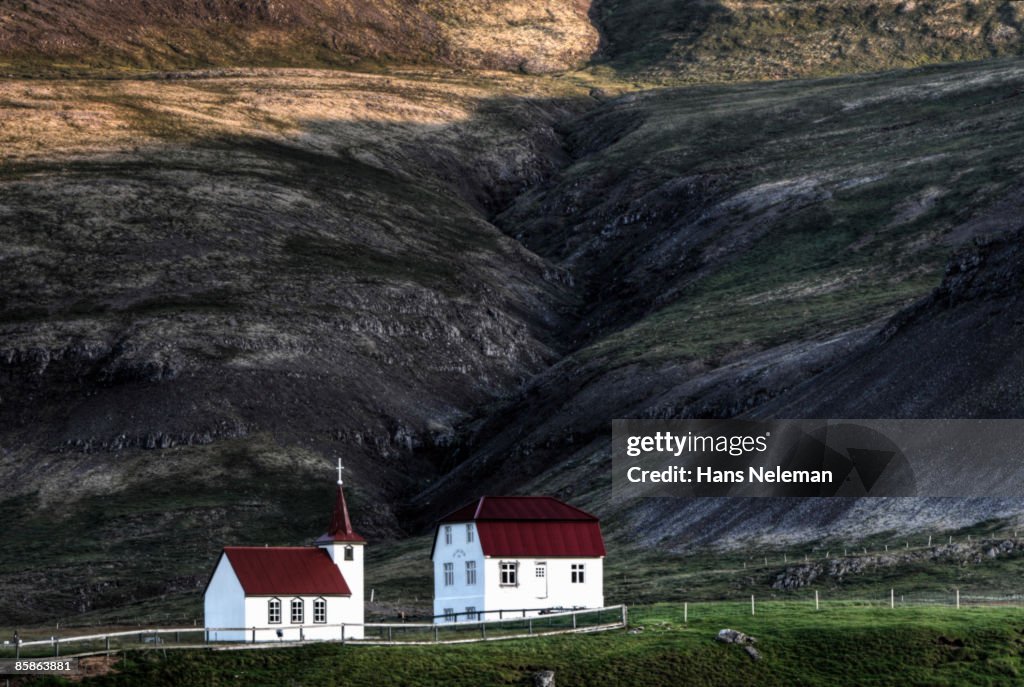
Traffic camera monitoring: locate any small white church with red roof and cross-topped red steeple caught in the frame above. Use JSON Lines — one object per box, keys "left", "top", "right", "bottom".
{"left": 204, "top": 462, "right": 366, "bottom": 642}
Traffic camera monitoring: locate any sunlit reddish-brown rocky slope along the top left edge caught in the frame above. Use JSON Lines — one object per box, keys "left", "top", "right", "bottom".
{"left": 0, "top": 0, "right": 598, "bottom": 72}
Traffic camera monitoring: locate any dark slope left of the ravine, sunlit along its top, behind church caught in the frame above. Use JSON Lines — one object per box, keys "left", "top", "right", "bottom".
{"left": 0, "top": 71, "right": 594, "bottom": 622}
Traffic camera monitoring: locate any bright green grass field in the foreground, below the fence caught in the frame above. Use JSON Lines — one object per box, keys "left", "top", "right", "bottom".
{"left": 19, "top": 602, "right": 1024, "bottom": 687}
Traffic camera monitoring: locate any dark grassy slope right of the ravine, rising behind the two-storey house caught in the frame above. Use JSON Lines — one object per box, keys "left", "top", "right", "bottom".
{"left": 411, "top": 61, "right": 1024, "bottom": 546}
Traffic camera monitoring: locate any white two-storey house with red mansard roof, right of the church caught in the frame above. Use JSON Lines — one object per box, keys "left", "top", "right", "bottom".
{"left": 430, "top": 497, "right": 605, "bottom": 622}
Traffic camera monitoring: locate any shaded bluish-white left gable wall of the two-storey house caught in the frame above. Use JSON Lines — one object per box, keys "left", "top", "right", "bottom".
{"left": 433, "top": 522, "right": 486, "bottom": 622}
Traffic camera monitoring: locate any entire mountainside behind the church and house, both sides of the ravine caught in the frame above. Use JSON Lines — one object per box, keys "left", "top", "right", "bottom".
{"left": 0, "top": 0, "right": 1024, "bottom": 622}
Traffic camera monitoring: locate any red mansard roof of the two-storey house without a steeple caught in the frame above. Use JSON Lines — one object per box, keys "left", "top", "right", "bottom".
{"left": 431, "top": 497, "right": 605, "bottom": 558}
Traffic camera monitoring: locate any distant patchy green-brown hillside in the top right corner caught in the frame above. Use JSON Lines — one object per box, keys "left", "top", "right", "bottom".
{"left": 594, "top": 0, "right": 1024, "bottom": 83}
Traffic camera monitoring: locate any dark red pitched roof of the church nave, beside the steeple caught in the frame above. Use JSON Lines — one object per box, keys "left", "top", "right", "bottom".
{"left": 224, "top": 547, "right": 352, "bottom": 596}
